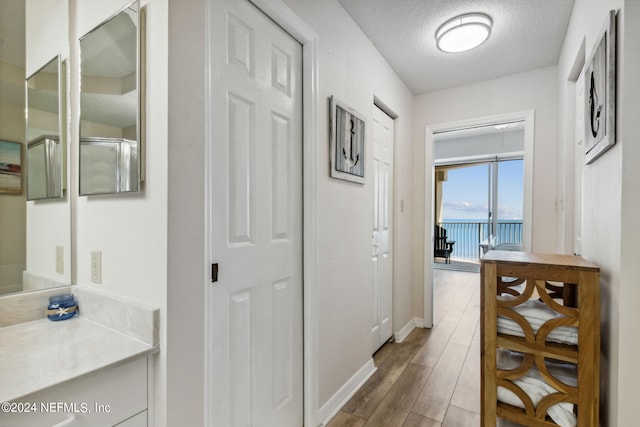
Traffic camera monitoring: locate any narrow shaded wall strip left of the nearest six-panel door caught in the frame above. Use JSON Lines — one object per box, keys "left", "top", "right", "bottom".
{"left": 168, "top": 0, "right": 209, "bottom": 426}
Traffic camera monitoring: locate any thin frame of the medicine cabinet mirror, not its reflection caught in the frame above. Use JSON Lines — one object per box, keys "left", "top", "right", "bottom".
{"left": 78, "top": 0, "right": 146, "bottom": 196}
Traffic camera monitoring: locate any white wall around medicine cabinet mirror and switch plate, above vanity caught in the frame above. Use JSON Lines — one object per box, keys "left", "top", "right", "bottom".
{"left": 69, "top": 0, "right": 168, "bottom": 426}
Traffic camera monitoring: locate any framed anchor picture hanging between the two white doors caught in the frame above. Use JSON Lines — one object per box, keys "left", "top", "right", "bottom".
{"left": 330, "top": 96, "right": 366, "bottom": 184}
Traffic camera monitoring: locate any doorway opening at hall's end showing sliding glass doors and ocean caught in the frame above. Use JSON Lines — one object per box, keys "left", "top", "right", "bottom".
{"left": 433, "top": 121, "right": 524, "bottom": 271}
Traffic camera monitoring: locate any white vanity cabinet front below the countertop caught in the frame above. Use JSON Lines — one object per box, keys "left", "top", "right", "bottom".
{"left": 0, "top": 357, "right": 148, "bottom": 427}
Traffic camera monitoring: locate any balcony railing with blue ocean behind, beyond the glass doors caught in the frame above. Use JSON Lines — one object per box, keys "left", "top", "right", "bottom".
{"left": 438, "top": 220, "right": 522, "bottom": 261}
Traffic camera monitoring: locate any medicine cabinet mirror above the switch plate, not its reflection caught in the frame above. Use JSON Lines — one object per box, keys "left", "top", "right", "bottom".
{"left": 80, "top": 1, "right": 143, "bottom": 196}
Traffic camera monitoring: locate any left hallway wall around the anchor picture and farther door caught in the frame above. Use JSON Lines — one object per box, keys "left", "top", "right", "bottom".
{"left": 278, "top": 0, "right": 413, "bottom": 406}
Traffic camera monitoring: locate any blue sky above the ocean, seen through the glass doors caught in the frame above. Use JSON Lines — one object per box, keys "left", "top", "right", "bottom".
{"left": 442, "top": 160, "right": 524, "bottom": 221}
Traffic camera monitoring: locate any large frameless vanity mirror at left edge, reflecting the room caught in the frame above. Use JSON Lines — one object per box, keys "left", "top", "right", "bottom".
{"left": 0, "top": 0, "right": 73, "bottom": 298}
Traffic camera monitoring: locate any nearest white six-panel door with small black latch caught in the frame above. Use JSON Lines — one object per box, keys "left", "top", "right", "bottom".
{"left": 207, "top": 0, "right": 303, "bottom": 427}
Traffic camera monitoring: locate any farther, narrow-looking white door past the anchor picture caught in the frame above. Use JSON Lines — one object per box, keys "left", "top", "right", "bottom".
{"left": 371, "top": 105, "right": 393, "bottom": 352}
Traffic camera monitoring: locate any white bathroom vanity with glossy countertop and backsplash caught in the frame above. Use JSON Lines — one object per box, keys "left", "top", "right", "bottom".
{"left": 0, "top": 286, "right": 158, "bottom": 427}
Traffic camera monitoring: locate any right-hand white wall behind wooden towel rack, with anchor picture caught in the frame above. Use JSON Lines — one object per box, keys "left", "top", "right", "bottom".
{"left": 558, "top": 0, "right": 640, "bottom": 426}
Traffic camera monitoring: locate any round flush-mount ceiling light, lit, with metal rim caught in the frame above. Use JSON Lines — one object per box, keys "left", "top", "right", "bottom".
{"left": 436, "top": 13, "right": 493, "bottom": 53}
